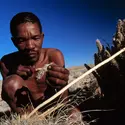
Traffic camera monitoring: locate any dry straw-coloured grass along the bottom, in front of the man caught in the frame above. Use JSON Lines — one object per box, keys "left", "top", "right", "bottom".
{"left": 0, "top": 93, "right": 85, "bottom": 125}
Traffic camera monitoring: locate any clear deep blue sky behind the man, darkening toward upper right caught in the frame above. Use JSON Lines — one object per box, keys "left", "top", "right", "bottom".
{"left": 0, "top": 0, "right": 125, "bottom": 67}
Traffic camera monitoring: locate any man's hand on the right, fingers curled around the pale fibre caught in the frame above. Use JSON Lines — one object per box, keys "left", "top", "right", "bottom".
{"left": 47, "top": 64, "right": 69, "bottom": 88}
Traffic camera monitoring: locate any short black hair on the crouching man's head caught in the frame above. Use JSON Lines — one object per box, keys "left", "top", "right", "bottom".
{"left": 10, "top": 12, "right": 42, "bottom": 36}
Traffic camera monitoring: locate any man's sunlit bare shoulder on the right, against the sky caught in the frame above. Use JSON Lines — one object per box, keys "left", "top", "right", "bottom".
{"left": 42, "top": 48, "right": 64, "bottom": 66}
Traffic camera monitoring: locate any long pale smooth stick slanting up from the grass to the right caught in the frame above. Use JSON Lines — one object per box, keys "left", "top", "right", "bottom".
{"left": 27, "top": 48, "right": 125, "bottom": 119}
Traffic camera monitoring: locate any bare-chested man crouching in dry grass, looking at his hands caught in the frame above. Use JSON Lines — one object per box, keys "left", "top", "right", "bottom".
{"left": 0, "top": 12, "right": 69, "bottom": 113}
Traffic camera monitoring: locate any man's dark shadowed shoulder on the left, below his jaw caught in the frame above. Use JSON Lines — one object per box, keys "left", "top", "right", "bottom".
{"left": 1, "top": 51, "right": 19, "bottom": 62}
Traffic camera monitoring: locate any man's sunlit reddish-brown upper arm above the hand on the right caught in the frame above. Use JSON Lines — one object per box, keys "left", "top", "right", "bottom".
{"left": 50, "top": 49, "right": 65, "bottom": 67}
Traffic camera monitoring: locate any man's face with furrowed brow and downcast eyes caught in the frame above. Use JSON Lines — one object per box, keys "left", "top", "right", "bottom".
{"left": 12, "top": 22, "right": 44, "bottom": 63}
